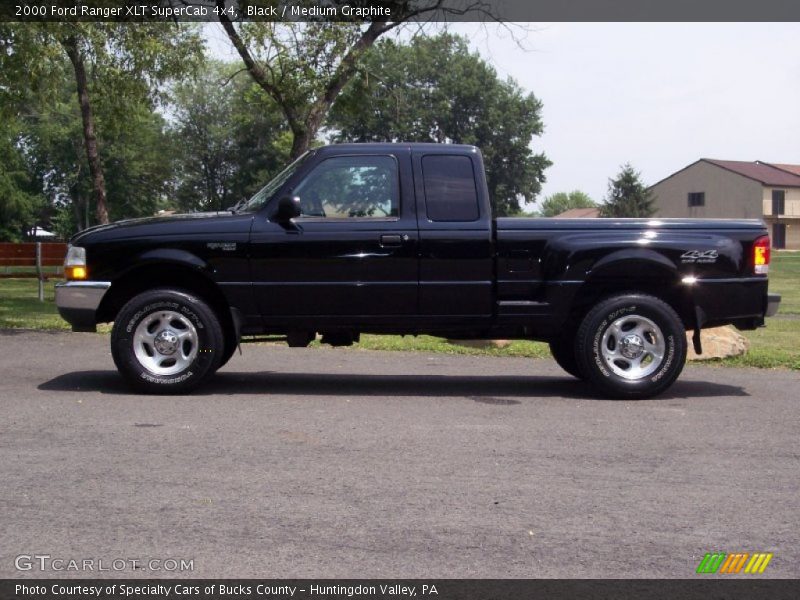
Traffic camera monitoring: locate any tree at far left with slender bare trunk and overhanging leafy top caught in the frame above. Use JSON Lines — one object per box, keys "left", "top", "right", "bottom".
{"left": 0, "top": 22, "right": 202, "bottom": 223}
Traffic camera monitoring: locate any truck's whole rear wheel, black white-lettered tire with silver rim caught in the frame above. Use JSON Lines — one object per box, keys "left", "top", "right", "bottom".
{"left": 575, "top": 294, "right": 687, "bottom": 399}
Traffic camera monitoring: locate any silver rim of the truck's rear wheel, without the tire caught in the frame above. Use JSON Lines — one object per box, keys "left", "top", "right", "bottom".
{"left": 600, "top": 315, "right": 667, "bottom": 380}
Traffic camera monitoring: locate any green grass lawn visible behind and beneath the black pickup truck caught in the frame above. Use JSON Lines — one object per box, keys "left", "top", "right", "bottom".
{"left": 0, "top": 252, "right": 800, "bottom": 369}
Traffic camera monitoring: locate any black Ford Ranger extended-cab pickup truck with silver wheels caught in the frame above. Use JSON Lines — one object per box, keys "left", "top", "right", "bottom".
{"left": 56, "top": 144, "right": 780, "bottom": 398}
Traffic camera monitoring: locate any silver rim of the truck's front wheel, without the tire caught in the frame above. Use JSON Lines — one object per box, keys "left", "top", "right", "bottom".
{"left": 133, "top": 310, "right": 199, "bottom": 375}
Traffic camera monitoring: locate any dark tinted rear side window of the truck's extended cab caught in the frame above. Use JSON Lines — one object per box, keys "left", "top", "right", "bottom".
{"left": 422, "top": 154, "right": 480, "bottom": 221}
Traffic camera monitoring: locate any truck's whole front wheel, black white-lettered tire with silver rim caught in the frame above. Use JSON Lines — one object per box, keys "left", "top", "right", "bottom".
{"left": 111, "top": 288, "right": 225, "bottom": 394}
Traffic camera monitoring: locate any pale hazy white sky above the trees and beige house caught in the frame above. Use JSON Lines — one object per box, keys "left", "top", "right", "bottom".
{"left": 207, "top": 23, "right": 800, "bottom": 207}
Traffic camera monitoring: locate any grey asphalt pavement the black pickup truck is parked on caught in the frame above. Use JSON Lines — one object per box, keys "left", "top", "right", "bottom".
{"left": 0, "top": 331, "right": 800, "bottom": 578}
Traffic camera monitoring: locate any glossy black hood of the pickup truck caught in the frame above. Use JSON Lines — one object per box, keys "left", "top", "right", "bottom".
{"left": 70, "top": 211, "right": 253, "bottom": 245}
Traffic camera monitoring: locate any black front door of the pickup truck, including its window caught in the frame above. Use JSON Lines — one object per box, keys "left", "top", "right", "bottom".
{"left": 251, "top": 152, "right": 418, "bottom": 324}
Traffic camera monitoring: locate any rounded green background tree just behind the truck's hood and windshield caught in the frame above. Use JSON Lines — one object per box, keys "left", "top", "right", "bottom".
{"left": 172, "top": 61, "right": 291, "bottom": 210}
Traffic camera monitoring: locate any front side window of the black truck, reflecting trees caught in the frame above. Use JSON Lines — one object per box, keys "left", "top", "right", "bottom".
{"left": 294, "top": 156, "right": 400, "bottom": 219}
